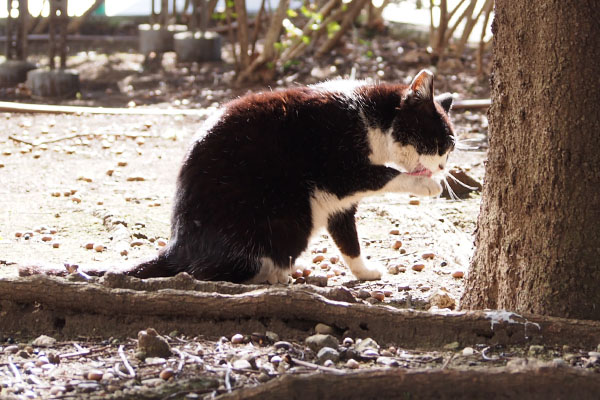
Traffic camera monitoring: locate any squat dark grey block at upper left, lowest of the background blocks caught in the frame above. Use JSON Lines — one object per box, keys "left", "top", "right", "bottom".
{"left": 26, "top": 69, "right": 79, "bottom": 98}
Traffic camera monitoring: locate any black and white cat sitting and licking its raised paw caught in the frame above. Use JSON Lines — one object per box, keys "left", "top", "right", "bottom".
{"left": 128, "top": 70, "right": 455, "bottom": 284}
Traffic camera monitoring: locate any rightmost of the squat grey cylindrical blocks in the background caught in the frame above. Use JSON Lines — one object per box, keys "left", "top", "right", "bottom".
{"left": 174, "top": 31, "right": 222, "bottom": 62}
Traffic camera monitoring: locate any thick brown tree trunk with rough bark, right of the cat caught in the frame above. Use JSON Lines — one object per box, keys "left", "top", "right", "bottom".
{"left": 462, "top": 0, "right": 600, "bottom": 320}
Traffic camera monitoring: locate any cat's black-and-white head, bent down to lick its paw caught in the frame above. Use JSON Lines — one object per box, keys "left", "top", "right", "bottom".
{"left": 392, "top": 70, "right": 455, "bottom": 176}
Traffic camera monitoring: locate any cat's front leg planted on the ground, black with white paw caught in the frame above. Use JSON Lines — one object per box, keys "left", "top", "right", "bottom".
{"left": 327, "top": 205, "right": 381, "bottom": 281}
